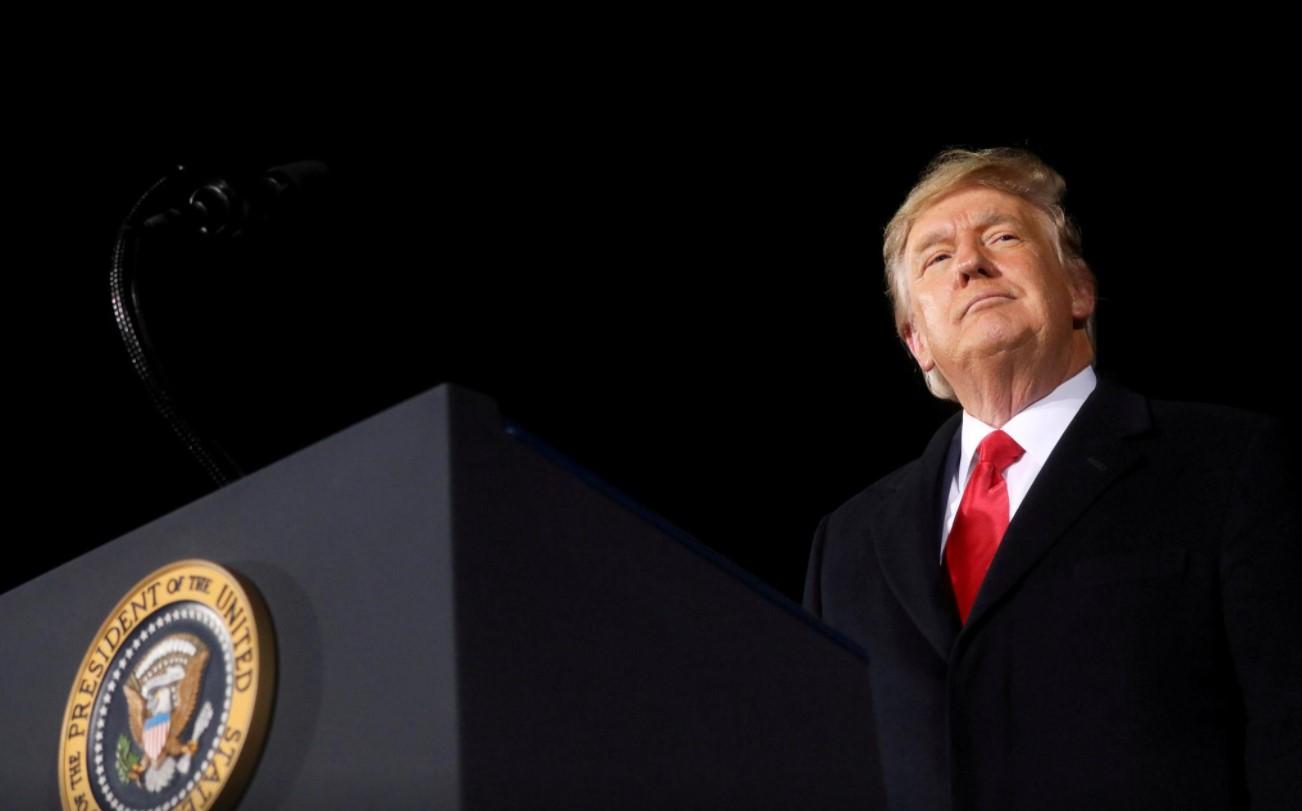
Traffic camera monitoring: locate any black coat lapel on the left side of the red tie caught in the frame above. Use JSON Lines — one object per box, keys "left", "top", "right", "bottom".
{"left": 872, "top": 411, "right": 962, "bottom": 661}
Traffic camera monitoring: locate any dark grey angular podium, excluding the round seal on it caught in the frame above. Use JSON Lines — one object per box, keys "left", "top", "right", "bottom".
{"left": 0, "top": 385, "right": 883, "bottom": 810}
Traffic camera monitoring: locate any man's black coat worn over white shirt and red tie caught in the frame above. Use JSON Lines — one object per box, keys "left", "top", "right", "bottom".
{"left": 805, "top": 378, "right": 1302, "bottom": 811}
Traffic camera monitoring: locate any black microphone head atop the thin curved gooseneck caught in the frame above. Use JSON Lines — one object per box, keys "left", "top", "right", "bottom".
{"left": 142, "top": 160, "right": 329, "bottom": 237}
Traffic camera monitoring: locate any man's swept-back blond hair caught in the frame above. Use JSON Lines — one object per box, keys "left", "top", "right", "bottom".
{"left": 881, "top": 147, "right": 1096, "bottom": 400}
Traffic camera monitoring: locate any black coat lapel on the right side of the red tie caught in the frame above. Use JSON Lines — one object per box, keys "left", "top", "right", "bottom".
{"left": 963, "top": 378, "right": 1150, "bottom": 634}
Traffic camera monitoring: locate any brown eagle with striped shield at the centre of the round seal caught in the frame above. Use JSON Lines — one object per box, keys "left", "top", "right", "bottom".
{"left": 117, "top": 633, "right": 212, "bottom": 791}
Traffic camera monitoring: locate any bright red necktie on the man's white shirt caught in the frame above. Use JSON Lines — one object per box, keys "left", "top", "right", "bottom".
{"left": 945, "top": 431, "right": 1026, "bottom": 622}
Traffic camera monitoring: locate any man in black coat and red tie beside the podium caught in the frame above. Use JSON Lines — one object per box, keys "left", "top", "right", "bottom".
{"left": 805, "top": 150, "right": 1302, "bottom": 811}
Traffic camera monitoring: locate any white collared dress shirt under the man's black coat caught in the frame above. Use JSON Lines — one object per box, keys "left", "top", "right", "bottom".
{"left": 940, "top": 366, "right": 1098, "bottom": 562}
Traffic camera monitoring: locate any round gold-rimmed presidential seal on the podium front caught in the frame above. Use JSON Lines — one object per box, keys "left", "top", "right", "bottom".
{"left": 59, "top": 560, "right": 275, "bottom": 811}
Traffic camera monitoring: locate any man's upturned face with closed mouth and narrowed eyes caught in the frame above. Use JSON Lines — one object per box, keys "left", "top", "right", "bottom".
{"left": 904, "top": 186, "right": 1094, "bottom": 381}
